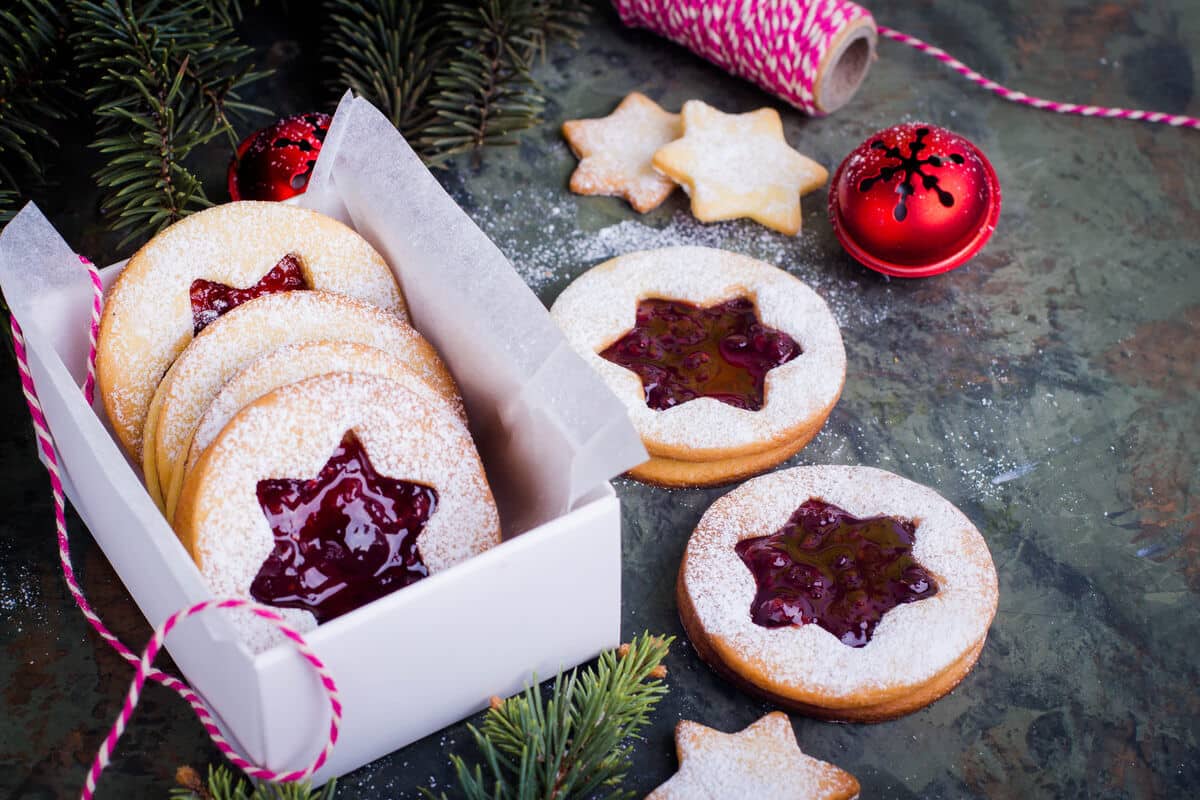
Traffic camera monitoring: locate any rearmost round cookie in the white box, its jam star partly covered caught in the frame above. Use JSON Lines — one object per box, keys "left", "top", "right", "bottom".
{"left": 96, "top": 201, "right": 407, "bottom": 457}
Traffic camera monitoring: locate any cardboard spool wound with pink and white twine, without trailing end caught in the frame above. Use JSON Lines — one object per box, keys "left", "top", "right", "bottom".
{"left": 613, "top": 0, "right": 878, "bottom": 115}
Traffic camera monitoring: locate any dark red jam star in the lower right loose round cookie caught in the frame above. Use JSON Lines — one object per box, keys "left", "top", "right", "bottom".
{"left": 734, "top": 499, "right": 937, "bottom": 648}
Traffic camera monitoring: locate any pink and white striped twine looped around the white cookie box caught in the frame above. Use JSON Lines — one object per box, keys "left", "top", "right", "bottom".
{"left": 10, "top": 255, "right": 342, "bottom": 800}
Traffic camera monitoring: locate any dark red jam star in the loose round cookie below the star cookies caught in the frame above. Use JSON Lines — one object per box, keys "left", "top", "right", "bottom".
{"left": 600, "top": 297, "right": 800, "bottom": 411}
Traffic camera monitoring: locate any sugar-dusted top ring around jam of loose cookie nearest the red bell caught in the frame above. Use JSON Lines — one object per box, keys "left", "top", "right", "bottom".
{"left": 551, "top": 247, "right": 846, "bottom": 452}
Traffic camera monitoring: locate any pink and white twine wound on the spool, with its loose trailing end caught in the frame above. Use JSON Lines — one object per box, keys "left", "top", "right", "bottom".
{"left": 613, "top": 0, "right": 1200, "bottom": 130}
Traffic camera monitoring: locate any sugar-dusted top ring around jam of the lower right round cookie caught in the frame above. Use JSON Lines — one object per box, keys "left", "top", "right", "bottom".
{"left": 684, "top": 465, "right": 998, "bottom": 705}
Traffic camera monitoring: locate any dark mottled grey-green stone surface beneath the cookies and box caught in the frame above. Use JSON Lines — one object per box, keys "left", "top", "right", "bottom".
{"left": 0, "top": 0, "right": 1200, "bottom": 800}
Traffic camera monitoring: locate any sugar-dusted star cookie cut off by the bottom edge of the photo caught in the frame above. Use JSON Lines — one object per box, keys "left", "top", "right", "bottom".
{"left": 646, "top": 711, "right": 858, "bottom": 800}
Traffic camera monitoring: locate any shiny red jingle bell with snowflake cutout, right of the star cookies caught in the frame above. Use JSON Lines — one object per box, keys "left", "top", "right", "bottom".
{"left": 829, "top": 122, "right": 1000, "bottom": 278}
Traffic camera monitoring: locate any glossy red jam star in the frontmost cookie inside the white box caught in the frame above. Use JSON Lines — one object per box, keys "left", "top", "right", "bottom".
{"left": 250, "top": 433, "right": 438, "bottom": 622}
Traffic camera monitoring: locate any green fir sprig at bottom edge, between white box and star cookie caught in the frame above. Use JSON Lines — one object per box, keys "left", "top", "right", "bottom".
{"left": 422, "top": 633, "right": 671, "bottom": 800}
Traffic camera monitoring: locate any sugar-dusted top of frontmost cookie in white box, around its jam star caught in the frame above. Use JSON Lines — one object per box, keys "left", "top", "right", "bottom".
{"left": 176, "top": 373, "right": 500, "bottom": 650}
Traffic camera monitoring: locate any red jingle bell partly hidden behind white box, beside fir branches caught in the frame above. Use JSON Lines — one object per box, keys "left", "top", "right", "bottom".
{"left": 228, "top": 112, "right": 331, "bottom": 200}
